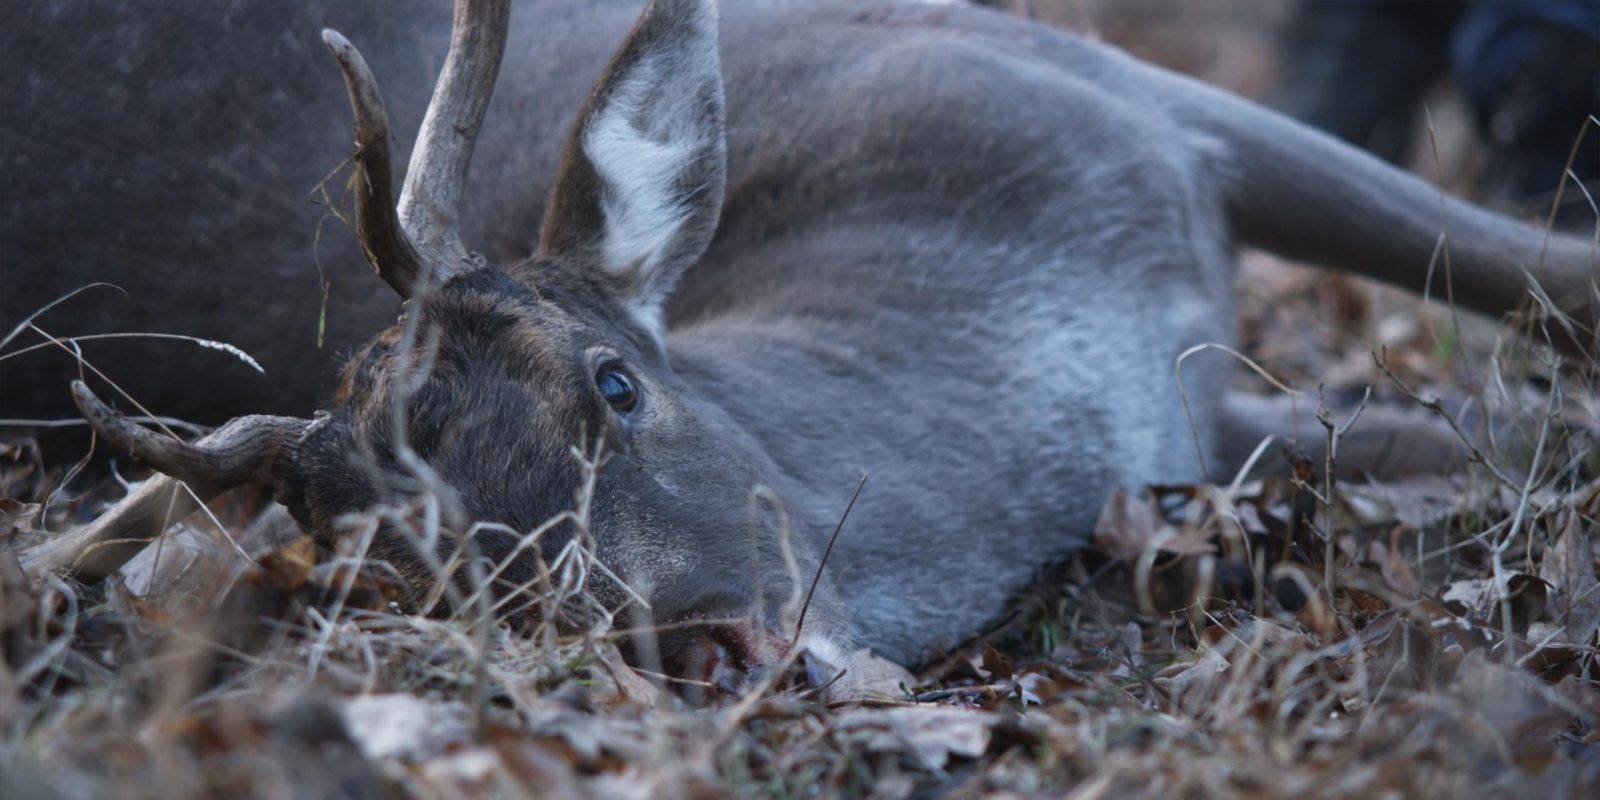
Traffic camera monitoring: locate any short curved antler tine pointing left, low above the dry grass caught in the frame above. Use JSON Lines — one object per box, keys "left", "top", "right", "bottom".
{"left": 72, "top": 381, "right": 310, "bottom": 486}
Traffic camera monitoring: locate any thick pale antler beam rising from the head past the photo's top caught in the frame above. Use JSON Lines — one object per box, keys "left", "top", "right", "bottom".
{"left": 400, "top": 0, "right": 510, "bottom": 274}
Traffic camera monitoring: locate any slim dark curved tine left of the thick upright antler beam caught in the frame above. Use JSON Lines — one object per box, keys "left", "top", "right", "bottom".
{"left": 322, "top": 29, "right": 426, "bottom": 298}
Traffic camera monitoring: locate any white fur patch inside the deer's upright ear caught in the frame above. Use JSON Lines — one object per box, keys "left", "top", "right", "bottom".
{"left": 582, "top": 28, "right": 722, "bottom": 336}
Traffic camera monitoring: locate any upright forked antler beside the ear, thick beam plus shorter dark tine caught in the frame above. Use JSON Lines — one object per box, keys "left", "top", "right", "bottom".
{"left": 322, "top": 0, "right": 510, "bottom": 298}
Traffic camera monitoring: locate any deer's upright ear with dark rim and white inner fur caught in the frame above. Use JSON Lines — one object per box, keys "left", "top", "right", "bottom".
{"left": 539, "top": 0, "right": 728, "bottom": 338}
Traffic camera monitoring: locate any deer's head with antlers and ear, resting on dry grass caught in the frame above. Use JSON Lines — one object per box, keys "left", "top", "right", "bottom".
{"left": 74, "top": 0, "right": 840, "bottom": 691}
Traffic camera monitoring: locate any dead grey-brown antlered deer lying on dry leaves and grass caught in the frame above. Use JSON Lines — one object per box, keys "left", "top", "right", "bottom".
{"left": 6, "top": 0, "right": 1600, "bottom": 688}
